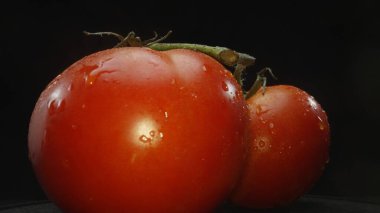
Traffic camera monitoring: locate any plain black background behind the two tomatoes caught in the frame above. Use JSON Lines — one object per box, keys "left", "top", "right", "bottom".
{"left": 0, "top": 0, "right": 380, "bottom": 203}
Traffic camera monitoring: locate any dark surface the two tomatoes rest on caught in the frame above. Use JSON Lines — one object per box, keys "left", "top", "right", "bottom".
{"left": 0, "top": 196, "right": 380, "bottom": 213}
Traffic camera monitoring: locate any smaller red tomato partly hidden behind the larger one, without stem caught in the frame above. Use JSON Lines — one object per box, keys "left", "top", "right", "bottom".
{"left": 232, "top": 85, "right": 330, "bottom": 208}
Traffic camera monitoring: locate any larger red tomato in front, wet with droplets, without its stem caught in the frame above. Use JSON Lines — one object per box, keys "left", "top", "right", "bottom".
{"left": 28, "top": 48, "right": 249, "bottom": 212}
